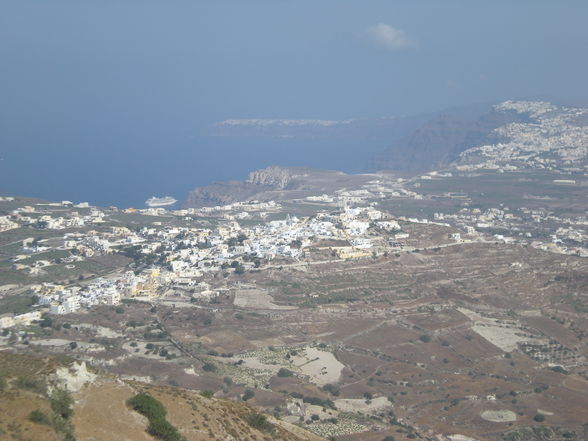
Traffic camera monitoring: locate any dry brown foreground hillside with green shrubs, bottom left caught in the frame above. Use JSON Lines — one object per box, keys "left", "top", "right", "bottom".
{"left": 0, "top": 352, "right": 322, "bottom": 441}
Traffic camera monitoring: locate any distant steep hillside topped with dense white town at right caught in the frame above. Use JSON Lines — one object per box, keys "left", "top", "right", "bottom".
{"left": 368, "top": 101, "right": 587, "bottom": 171}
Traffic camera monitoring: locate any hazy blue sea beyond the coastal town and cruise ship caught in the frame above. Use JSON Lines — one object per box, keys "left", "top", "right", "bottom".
{"left": 0, "top": 133, "right": 386, "bottom": 208}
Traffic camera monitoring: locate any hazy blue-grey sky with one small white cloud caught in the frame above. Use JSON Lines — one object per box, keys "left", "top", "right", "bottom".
{"left": 0, "top": 0, "right": 588, "bottom": 204}
